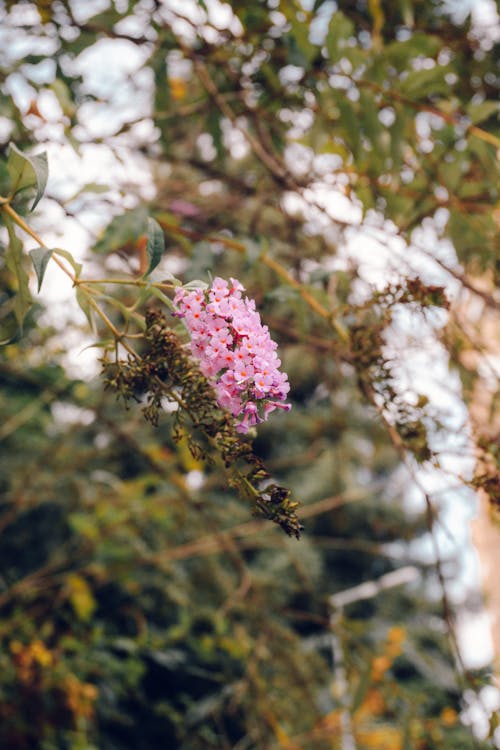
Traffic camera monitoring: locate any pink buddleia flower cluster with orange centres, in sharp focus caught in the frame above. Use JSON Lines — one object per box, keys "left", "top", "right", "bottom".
{"left": 174, "top": 278, "right": 291, "bottom": 433}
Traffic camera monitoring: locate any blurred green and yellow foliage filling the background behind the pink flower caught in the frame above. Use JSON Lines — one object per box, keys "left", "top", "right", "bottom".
{"left": 0, "top": 0, "right": 499, "bottom": 750}
